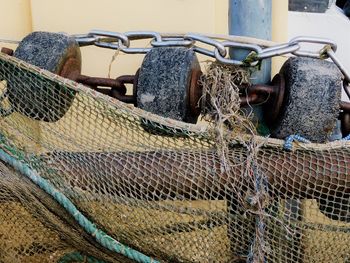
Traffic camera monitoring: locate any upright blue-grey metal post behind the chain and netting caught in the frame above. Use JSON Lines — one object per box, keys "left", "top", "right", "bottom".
{"left": 228, "top": 0, "right": 272, "bottom": 256}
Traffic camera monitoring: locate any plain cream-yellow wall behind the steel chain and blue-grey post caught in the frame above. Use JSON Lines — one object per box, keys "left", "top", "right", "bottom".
{"left": 0, "top": 0, "right": 288, "bottom": 76}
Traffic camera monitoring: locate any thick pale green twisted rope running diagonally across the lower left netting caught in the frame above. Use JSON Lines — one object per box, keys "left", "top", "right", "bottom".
{"left": 0, "top": 146, "right": 158, "bottom": 263}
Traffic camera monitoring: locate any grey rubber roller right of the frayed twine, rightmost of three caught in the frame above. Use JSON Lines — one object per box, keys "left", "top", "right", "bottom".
{"left": 270, "top": 57, "right": 342, "bottom": 143}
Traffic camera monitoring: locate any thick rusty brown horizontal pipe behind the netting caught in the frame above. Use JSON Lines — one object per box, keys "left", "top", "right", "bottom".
{"left": 50, "top": 147, "right": 350, "bottom": 200}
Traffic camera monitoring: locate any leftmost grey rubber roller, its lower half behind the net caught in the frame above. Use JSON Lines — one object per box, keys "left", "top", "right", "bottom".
{"left": 7, "top": 32, "right": 81, "bottom": 122}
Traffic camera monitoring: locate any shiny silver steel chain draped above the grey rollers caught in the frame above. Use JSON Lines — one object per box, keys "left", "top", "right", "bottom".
{"left": 74, "top": 30, "right": 350, "bottom": 92}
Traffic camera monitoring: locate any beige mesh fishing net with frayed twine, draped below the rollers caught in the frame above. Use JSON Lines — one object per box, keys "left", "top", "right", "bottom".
{"left": 0, "top": 54, "right": 350, "bottom": 263}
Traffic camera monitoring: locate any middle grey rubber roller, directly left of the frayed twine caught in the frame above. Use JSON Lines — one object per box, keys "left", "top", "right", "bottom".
{"left": 137, "top": 47, "right": 200, "bottom": 123}
